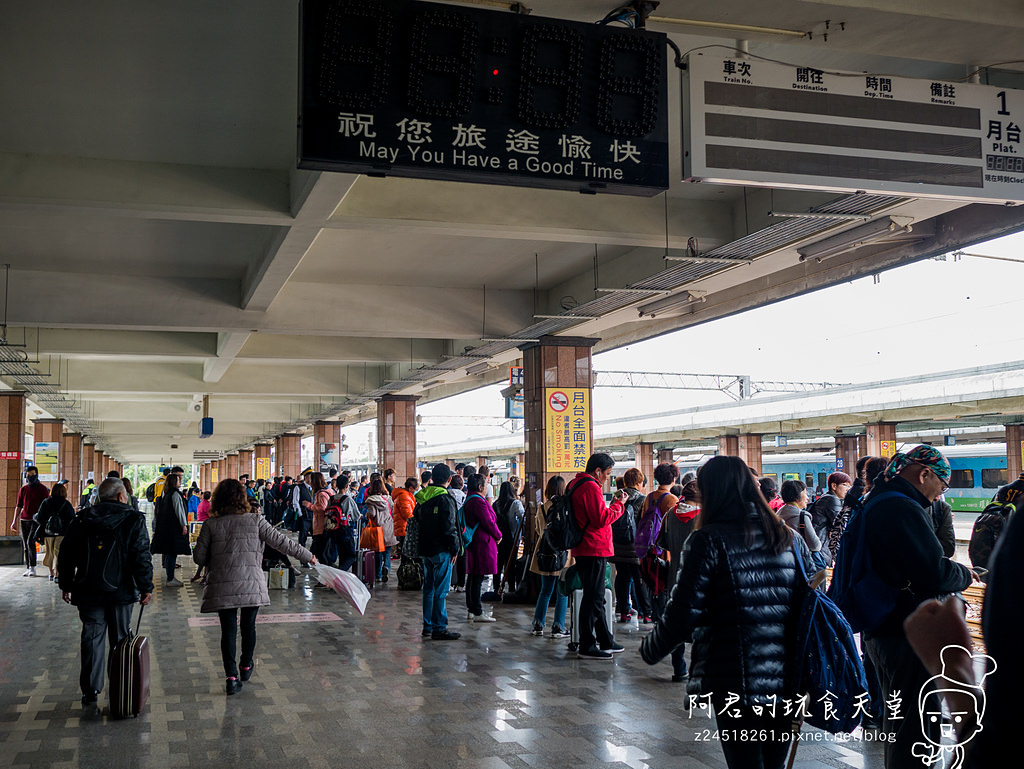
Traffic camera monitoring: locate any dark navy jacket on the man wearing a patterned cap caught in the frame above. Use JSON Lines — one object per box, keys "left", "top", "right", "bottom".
{"left": 864, "top": 476, "right": 971, "bottom": 637}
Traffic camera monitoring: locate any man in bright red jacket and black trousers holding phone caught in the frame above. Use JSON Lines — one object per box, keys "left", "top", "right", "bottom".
{"left": 566, "top": 454, "right": 626, "bottom": 659}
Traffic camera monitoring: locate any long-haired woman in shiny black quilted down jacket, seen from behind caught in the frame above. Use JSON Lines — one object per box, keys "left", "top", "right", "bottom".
{"left": 640, "top": 456, "right": 810, "bottom": 769}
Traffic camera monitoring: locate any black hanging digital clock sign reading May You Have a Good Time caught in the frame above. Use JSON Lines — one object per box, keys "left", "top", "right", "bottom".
{"left": 299, "top": 0, "right": 669, "bottom": 196}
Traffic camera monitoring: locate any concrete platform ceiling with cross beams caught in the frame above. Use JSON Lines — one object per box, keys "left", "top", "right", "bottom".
{"left": 0, "top": 0, "right": 1024, "bottom": 462}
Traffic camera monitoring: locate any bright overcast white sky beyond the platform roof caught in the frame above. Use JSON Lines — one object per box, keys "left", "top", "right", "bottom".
{"left": 352, "top": 228, "right": 1024, "bottom": 456}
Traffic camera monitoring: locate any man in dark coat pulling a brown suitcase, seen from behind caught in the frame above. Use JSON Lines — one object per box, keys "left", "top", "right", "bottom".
{"left": 57, "top": 478, "right": 153, "bottom": 715}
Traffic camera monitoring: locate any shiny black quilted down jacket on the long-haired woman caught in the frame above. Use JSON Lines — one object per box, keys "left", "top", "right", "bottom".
{"left": 640, "top": 507, "right": 810, "bottom": 706}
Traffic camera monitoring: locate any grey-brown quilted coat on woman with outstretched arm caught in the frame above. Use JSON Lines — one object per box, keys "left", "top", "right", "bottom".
{"left": 193, "top": 513, "right": 313, "bottom": 612}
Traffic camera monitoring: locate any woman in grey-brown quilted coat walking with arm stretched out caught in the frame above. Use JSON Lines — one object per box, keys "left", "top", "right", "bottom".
{"left": 193, "top": 478, "right": 316, "bottom": 694}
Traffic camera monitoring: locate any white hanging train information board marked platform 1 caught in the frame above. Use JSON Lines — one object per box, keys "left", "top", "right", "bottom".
{"left": 684, "top": 55, "right": 1024, "bottom": 203}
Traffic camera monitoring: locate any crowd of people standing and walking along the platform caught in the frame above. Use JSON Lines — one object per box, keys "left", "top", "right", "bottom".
{"left": 9, "top": 445, "right": 1024, "bottom": 768}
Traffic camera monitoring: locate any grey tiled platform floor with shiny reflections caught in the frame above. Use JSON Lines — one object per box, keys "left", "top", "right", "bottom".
{"left": 0, "top": 558, "right": 883, "bottom": 769}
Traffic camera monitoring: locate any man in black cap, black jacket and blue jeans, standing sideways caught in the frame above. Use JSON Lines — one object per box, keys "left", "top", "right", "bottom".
{"left": 413, "top": 464, "right": 460, "bottom": 641}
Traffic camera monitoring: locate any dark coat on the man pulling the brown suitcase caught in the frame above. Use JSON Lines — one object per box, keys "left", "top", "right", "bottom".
{"left": 57, "top": 502, "right": 153, "bottom": 606}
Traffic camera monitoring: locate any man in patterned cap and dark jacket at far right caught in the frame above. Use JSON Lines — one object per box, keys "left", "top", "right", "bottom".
{"left": 860, "top": 445, "right": 973, "bottom": 769}
